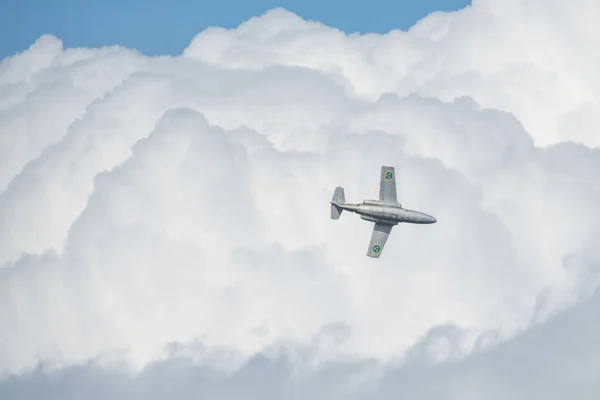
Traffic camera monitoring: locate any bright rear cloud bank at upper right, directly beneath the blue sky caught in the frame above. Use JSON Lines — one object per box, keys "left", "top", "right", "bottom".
{"left": 184, "top": 0, "right": 600, "bottom": 145}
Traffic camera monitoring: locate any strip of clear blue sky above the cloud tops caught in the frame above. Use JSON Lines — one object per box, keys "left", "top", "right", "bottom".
{"left": 0, "top": 0, "right": 471, "bottom": 58}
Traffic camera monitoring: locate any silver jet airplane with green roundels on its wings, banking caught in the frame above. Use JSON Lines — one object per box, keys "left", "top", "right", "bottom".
{"left": 329, "top": 166, "right": 437, "bottom": 258}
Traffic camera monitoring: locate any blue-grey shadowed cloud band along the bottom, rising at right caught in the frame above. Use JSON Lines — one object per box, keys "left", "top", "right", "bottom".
{"left": 0, "top": 291, "right": 600, "bottom": 400}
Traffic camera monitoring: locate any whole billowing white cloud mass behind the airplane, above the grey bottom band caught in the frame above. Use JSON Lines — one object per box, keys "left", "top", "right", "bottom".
{"left": 0, "top": 0, "right": 600, "bottom": 398}
